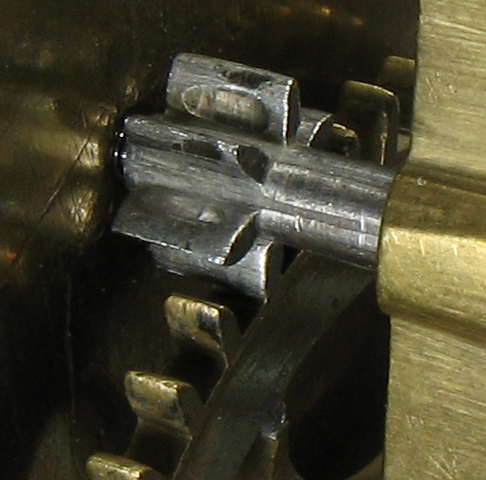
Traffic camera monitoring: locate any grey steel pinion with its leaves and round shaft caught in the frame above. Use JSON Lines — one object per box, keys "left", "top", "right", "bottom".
{"left": 113, "top": 54, "right": 398, "bottom": 288}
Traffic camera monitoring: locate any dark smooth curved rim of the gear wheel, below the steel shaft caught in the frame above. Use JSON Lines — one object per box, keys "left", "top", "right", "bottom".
{"left": 175, "top": 257, "right": 370, "bottom": 480}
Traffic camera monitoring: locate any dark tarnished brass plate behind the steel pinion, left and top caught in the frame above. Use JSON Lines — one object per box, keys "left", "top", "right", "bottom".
{"left": 0, "top": 0, "right": 417, "bottom": 479}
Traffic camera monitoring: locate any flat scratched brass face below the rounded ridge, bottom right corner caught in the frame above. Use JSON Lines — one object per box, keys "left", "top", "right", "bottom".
{"left": 385, "top": 318, "right": 486, "bottom": 480}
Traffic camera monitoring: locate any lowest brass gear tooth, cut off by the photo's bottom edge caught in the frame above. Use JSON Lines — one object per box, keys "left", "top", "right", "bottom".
{"left": 86, "top": 453, "right": 169, "bottom": 480}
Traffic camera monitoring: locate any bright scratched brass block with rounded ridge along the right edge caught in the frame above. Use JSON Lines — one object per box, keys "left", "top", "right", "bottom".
{"left": 379, "top": 0, "right": 486, "bottom": 480}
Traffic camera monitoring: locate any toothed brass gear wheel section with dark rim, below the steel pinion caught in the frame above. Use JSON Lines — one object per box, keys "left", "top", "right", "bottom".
{"left": 88, "top": 255, "right": 381, "bottom": 480}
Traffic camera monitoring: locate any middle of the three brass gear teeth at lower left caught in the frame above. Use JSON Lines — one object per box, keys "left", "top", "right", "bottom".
{"left": 125, "top": 372, "right": 203, "bottom": 438}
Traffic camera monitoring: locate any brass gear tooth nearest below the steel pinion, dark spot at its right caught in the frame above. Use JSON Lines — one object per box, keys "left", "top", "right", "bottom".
{"left": 165, "top": 295, "right": 242, "bottom": 366}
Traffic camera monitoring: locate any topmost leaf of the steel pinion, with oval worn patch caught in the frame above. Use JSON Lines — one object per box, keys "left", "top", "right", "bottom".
{"left": 166, "top": 53, "right": 300, "bottom": 144}
